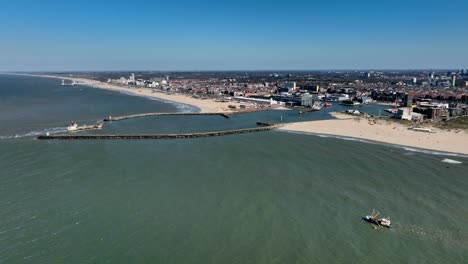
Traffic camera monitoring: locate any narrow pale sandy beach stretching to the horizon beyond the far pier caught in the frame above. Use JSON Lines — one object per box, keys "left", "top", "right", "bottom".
{"left": 0, "top": 73, "right": 247, "bottom": 113}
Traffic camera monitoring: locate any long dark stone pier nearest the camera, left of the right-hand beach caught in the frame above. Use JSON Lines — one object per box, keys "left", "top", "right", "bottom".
{"left": 37, "top": 122, "right": 280, "bottom": 140}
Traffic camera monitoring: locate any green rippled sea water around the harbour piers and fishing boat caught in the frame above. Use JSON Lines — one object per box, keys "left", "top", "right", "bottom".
{"left": 0, "top": 76, "right": 468, "bottom": 263}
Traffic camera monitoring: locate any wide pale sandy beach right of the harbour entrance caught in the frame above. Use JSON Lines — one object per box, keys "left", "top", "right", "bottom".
{"left": 280, "top": 113, "right": 468, "bottom": 155}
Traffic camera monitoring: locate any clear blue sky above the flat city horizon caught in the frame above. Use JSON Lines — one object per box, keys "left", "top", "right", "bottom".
{"left": 0, "top": 0, "right": 468, "bottom": 71}
